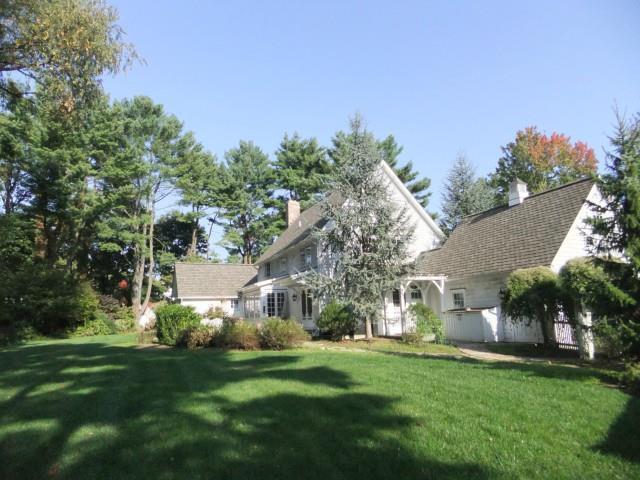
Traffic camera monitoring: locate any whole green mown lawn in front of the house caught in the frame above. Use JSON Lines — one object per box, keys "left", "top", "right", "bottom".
{"left": 0, "top": 336, "right": 640, "bottom": 480}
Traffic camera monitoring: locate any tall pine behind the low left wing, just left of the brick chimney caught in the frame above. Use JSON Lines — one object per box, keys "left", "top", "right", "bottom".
{"left": 220, "top": 141, "right": 284, "bottom": 263}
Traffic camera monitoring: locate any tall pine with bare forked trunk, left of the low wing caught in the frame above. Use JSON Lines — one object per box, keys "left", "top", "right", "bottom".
{"left": 96, "top": 97, "right": 184, "bottom": 318}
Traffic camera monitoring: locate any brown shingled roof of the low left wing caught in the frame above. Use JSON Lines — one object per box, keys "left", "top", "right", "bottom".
{"left": 172, "top": 263, "right": 258, "bottom": 298}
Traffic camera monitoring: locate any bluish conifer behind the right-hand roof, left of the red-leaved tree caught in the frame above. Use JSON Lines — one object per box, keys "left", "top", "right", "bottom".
{"left": 440, "top": 155, "right": 494, "bottom": 234}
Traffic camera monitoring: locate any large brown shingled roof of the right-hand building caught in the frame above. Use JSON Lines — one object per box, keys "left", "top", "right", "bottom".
{"left": 416, "top": 179, "right": 594, "bottom": 278}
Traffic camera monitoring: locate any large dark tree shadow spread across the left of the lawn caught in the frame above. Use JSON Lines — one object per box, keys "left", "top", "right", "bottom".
{"left": 0, "top": 343, "right": 495, "bottom": 480}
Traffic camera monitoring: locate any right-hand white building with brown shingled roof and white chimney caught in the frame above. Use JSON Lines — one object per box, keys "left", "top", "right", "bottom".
{"left": 416, "top": 179, "right": 600, "bottom": 342}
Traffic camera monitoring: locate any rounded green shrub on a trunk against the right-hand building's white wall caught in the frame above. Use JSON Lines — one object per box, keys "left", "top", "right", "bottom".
{"left": 502, "top": 267, "right": 563, "bottom": 345}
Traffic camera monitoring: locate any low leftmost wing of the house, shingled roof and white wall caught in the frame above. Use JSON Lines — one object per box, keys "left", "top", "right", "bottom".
{"left": 171, "top": 262, "right": 257, "bottom": 316}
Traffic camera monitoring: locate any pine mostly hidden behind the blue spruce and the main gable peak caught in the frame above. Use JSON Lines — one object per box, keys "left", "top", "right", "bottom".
{"left": 329, "top": 131, "right": 431, "bottom": 208}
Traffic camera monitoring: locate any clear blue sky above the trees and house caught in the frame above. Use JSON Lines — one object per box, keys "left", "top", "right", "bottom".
{"left": 105, "top": 0, "right": 640, "bottom": 218}
